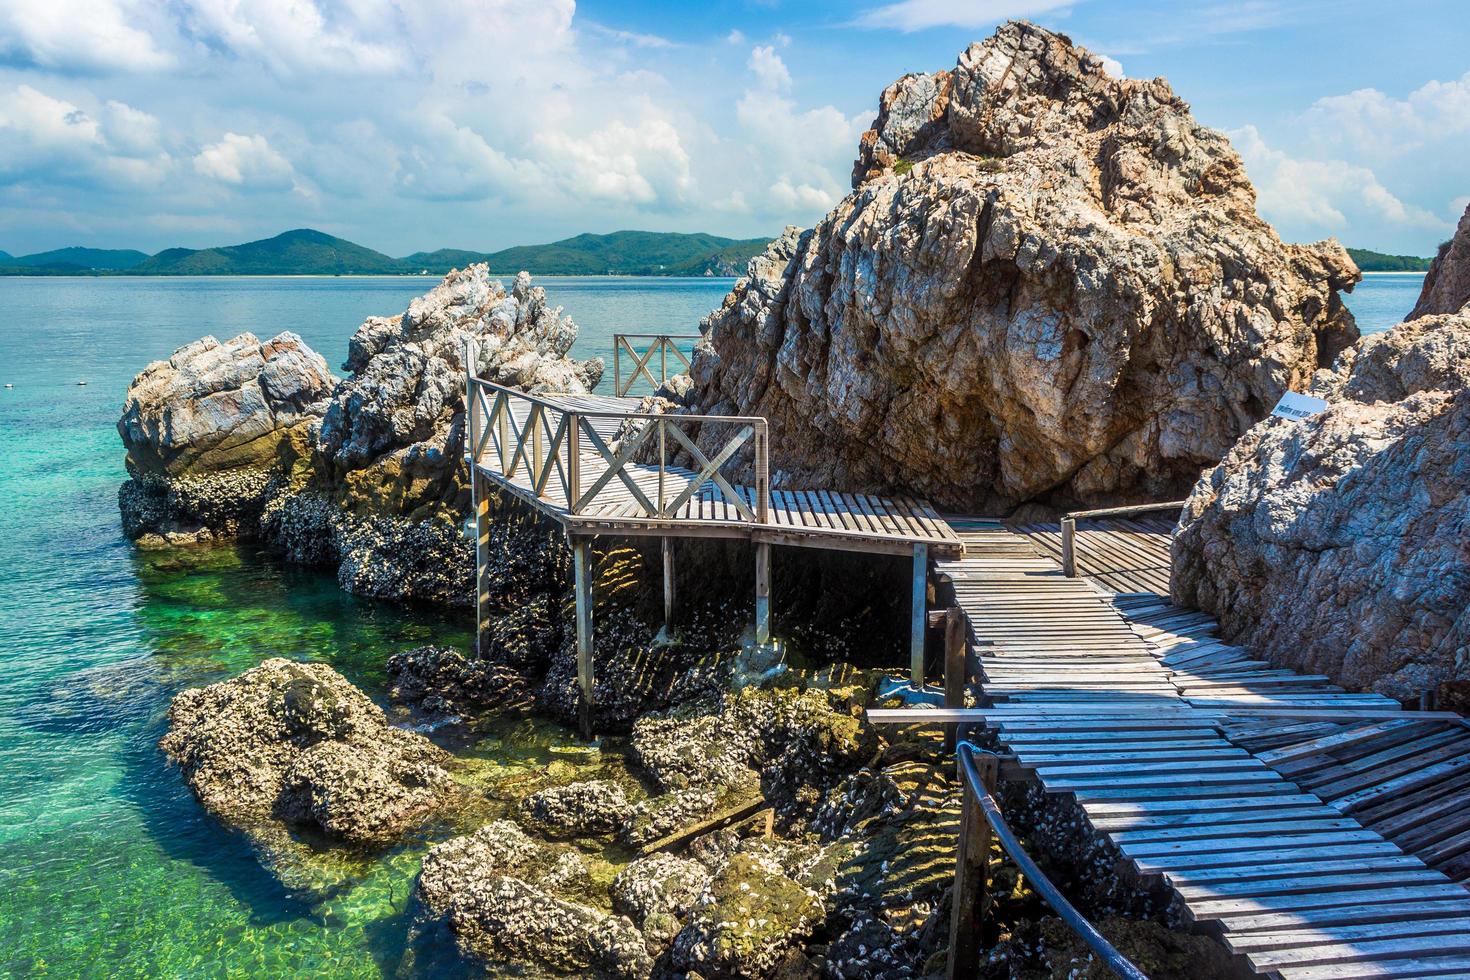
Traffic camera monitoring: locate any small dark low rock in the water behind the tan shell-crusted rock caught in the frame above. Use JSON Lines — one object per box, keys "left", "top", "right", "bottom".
{"left": 388, "top": 646, "right": 532, "bottom": 720}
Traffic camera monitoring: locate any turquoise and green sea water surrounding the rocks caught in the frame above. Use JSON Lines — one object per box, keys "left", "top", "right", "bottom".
{"left": 0, "top": 275, "right": 1423, "bottom": 977}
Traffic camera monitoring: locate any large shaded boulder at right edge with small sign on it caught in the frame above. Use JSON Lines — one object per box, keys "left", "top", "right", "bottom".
{"left": 1173, "top": 311, "right": 1470, "bottom": 698}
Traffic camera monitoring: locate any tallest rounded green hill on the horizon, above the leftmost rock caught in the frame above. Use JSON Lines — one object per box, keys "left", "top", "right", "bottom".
{"left": 128, "top": 228, "right": 404, "bottom": 276}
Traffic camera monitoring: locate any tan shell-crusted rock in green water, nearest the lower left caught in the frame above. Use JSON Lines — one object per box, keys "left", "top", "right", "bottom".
{"left": 159, "top": 660, "right": 456, "bottom": 887}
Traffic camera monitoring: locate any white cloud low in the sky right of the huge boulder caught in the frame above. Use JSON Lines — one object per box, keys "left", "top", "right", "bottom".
{"left": 1229, "top": 126, "right": 1449, "bottom": 241}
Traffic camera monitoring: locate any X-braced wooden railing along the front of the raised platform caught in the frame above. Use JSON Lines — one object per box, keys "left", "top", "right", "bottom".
{"left": 465, "top": 340, "right": 770, "bottom": 525}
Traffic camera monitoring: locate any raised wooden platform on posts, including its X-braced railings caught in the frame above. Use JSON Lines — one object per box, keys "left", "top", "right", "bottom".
{"left": 465, "top": 335, "right": 964, "bottom": 732}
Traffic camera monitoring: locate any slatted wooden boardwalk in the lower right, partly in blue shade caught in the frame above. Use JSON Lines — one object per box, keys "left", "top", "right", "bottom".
{"left": 941, "top": 519, "right": 1470, "bottom": 980}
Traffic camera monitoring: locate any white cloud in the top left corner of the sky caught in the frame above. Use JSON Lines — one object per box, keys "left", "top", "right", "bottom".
{"left": 0, "top": 0, "right": 173, "bottom": 72}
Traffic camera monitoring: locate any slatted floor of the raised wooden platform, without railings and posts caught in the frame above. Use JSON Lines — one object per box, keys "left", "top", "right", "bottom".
{"left": 478, "top": 395, "right": 963, "bottom": 557}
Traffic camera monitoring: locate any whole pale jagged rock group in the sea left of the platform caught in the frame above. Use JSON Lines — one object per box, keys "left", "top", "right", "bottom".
{"left": 118, "top": 264, "right": 601, "bottom": 604}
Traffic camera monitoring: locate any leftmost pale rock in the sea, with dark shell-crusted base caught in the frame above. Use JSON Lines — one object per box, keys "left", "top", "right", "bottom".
{"left": 118, "top": 334, "right": 337, "bottom": 547}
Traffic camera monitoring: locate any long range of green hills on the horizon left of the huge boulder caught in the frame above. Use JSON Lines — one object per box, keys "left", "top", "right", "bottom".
{"left": 0, "top": 228, "right": 770, "bottom": 276}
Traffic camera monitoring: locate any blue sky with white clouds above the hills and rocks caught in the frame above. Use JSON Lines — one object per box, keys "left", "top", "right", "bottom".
{"left": 0, "top": 0, "right": 1470, "bottom": 256}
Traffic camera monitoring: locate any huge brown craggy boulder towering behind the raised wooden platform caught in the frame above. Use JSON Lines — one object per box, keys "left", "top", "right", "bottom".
{"left": 688, "top": 24, "right": 1358, "bottom": 510}
